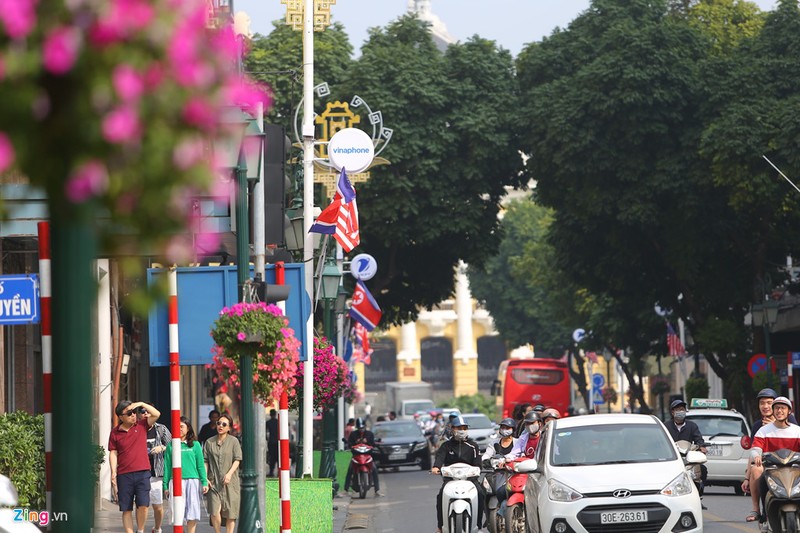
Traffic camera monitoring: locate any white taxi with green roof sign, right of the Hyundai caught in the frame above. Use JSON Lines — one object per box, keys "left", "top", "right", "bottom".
{"left": 686, "top": 398, "right": 750, "bottom": 495}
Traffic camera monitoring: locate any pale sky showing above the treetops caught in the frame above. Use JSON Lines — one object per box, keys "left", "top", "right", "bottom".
{"left": 232, "top": 0, "right": 776, "bottom": 56}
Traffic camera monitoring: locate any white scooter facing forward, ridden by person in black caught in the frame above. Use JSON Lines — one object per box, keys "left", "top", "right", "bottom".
{"left": 441, "top": 463, "right": 481, "bottom": 533}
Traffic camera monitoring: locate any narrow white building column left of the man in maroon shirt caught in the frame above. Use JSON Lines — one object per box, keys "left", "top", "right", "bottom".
{"left": 97, "top": 259, "right": 114, "bottom": 500}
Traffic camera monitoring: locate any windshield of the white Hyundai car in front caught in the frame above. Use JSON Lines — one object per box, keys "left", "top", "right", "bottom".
{"left": 550, "top": 424, "right": 677, "bottom": 466}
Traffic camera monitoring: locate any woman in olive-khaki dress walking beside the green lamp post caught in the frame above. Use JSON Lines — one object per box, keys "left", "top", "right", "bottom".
{"left": 203, "top": 414, "right": 242, "bottom": 533}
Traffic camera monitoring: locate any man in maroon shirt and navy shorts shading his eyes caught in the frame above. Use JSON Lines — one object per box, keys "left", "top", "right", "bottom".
{"left": 108, "top": 400, "right": 161, "bottom": 533}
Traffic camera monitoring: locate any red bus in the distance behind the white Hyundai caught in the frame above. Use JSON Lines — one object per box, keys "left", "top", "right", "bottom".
{"left": 496, "top": 358, "right": 570, "bottom": 418}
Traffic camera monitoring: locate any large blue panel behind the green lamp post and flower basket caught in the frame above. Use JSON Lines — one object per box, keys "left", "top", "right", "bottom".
{"left": 147, "top": 263, "right": 311, "bottom": 366}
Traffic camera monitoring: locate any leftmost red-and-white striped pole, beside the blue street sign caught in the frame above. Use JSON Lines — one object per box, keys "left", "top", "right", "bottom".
{"left": 37, "top": 222, "right": 53, "bottom": 529}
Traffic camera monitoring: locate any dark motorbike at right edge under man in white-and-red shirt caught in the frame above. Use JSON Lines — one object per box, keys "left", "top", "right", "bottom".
{"left": 762, "top": 449, "right": 800, "bottom": 533}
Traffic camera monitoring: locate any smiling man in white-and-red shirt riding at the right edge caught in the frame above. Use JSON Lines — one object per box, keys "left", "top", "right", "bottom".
{"left": 745, "top": 396, "right": 800, "bottom": 522}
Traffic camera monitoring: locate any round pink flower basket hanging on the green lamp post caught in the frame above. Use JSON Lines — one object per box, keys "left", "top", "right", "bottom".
{"left": 210, "top": 302, "right": 300, "bottom": 405}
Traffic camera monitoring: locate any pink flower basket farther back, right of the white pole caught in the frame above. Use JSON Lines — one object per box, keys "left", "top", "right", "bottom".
{"left": 289, "top": 337, "right": 361, "bottom": 411}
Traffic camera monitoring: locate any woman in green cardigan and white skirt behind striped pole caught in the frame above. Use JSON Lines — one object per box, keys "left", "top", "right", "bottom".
{"left": 163, "top": 416, "right": 208, "bottom": 533}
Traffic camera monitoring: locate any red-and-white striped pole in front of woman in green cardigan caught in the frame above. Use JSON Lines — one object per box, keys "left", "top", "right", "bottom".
{"left": 169, "top": 268, "right": 186, "bottom": 533}
